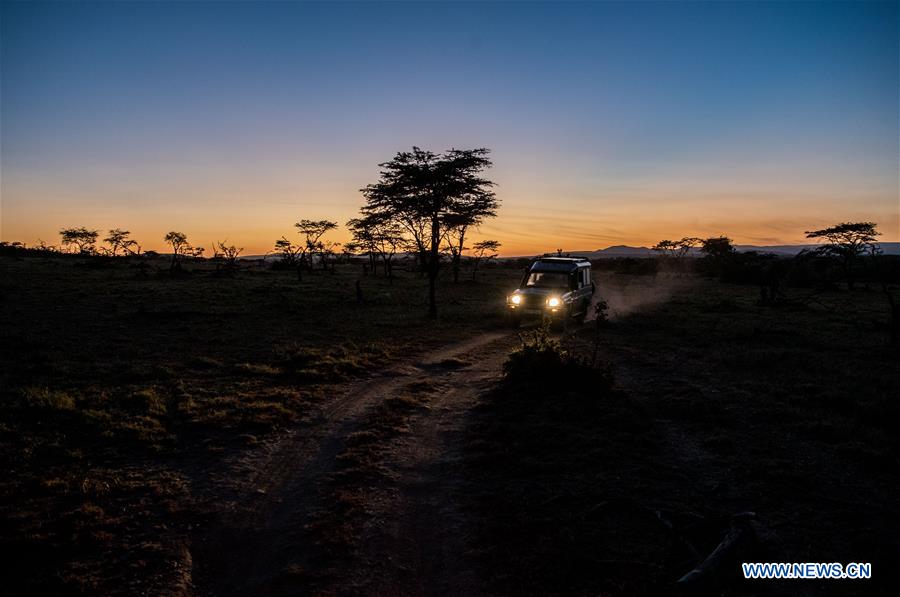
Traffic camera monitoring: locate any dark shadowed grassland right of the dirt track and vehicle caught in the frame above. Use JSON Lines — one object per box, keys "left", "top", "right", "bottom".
{"left": 468, "top": 276, "right": 900, "bottom": 595}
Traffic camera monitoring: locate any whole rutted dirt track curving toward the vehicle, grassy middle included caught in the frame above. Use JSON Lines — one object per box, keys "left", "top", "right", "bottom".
{"left": 192, "top": 332, "right": 516, "bottom": 595}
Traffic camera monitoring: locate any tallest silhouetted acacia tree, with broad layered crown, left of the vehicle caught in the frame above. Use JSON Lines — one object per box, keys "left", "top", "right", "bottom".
{"left": 362, "top": 147, "right": 497, "bottom": 317}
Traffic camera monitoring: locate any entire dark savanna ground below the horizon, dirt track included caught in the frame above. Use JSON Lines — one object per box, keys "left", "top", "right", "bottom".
{"left": 0, "top": 257, "right": 900, "bottom": 595}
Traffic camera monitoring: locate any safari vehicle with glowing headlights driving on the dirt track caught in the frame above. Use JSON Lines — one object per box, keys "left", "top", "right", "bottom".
{"left": 506, "top": 255, "right": 594, "bottom": 326}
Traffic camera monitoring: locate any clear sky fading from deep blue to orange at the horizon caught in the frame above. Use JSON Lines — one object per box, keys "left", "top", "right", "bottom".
{"left": 0, "top": 2, "right": 900, "bottom": 254}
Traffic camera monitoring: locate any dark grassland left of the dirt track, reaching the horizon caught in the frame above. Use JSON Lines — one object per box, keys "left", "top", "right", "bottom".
{"left": 0, "top": 257, "right": 518, "bottom": 594}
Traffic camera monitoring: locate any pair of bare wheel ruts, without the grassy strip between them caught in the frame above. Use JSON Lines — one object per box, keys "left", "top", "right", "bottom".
{"left": 192, "top": 332, "right": 515, "bottom": 595}
